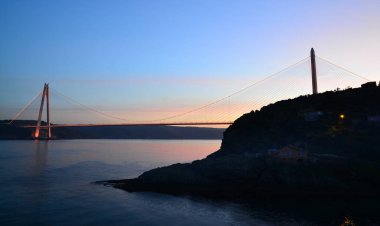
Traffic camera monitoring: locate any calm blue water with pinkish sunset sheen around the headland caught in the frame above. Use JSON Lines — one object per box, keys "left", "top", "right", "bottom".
{"left": 0, "top": 140, "right": 376, "bottom": 225}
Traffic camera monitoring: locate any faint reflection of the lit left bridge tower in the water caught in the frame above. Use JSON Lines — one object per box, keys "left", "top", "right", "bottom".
{"left": 32, "top": 140, "right": 49, "bottom": 176}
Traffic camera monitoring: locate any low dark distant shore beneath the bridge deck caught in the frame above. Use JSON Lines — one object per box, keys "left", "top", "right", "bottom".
{"left": 0, "top": 120, "right": 225, "bottom": 140}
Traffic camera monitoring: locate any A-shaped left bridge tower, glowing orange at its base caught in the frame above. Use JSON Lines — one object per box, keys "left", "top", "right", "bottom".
{"left": 34, "top": 83, "right": 51, "bottom": 139}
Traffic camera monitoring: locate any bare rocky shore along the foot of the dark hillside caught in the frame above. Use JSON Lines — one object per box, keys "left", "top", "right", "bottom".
{"left": 101, "top": 156, "right": 380, "bottom": 199}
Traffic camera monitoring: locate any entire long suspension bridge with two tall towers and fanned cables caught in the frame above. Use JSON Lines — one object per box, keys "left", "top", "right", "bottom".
{"left": 5, "top": 49, "right": 370, "bottom": 139}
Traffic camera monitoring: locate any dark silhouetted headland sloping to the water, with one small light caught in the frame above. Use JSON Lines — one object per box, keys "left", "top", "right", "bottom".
{"left": 108, "top": 87, "right": 380, "bottom": 196}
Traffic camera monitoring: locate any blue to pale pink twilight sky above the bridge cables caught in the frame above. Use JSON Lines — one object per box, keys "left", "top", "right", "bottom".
{"left": 0, "top": 0, "right": 380, "bottom": 122}
